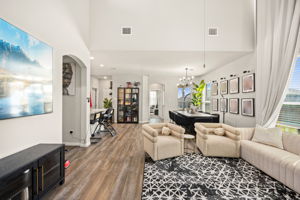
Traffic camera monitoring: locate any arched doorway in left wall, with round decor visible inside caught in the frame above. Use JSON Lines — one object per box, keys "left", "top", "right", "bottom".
{"left": 62, "top": 55, "right": 90, "bottom": 146}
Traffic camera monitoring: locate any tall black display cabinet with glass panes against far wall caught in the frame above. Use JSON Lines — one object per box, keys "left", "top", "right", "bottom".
{"left": 117, "top": 87, "right": 139, "bottom": 123}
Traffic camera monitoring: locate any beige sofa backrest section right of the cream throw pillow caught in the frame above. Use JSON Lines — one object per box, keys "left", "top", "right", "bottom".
{"left": 282, "top": 133, "right": 300, "bottom": 155}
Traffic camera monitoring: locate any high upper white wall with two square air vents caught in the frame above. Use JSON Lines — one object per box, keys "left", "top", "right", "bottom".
{"left": 90, "top": 0, "right": 255, "bottom": 52}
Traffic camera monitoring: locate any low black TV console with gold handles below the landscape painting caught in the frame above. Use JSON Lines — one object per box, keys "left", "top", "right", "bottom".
{"left": 0, "top": 144, "right": 65, "bottom": 200}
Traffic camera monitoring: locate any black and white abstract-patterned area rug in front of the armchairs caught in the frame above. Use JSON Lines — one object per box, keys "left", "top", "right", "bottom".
{"left": 142, "top": 154, "right": 300, "bottom": 200}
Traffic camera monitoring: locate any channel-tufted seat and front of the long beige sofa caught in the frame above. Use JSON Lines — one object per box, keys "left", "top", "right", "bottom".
{"left": 241, "top": 140, "right": 300, "bottom": 183}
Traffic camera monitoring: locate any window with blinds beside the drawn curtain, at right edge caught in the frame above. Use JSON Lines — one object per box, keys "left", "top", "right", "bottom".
{"left": 277, "top": 57, "right": 300, "bottom": 134}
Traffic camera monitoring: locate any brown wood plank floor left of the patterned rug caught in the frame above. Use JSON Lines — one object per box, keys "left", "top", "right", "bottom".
{"left": 45, "top": 124, "right": 145, "bottom": 200}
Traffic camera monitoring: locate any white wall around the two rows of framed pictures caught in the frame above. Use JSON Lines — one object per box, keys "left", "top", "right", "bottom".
{"left": 196, "top": 53, "right": 258, "bottom": 127}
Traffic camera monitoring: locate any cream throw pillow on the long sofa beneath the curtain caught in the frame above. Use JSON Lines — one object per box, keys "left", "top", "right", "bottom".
{"left": 252, "top": 126, "right": 283, "bottom": 149}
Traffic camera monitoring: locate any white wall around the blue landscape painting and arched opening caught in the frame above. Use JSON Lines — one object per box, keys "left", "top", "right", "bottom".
{"left": 0, "top": 0, "right": 90, "bottom": 157}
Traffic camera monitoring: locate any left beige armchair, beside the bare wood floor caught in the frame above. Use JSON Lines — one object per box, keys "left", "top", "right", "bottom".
{"left": 143, "top": 123, "right": 185, "bottom": 161}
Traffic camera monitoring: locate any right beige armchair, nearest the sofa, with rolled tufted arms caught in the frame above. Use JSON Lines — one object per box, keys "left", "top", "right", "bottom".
{"left": 195, "top": 123, "right": 240, "bottom": 158}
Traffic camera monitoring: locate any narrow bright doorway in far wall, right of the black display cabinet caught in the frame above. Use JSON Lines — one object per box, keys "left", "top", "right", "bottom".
{"left": 149, "top": 83, "right": 165, "bottom": 123}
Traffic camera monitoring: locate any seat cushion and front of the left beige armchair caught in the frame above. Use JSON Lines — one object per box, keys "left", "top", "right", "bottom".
{"left": 157, "top": 135, "right": 181, "bottom": 160}
